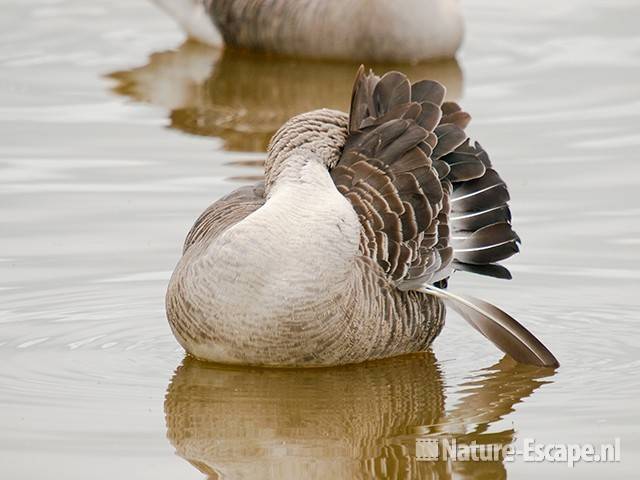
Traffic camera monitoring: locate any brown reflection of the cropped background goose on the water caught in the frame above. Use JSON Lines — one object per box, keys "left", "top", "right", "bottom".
{"left": 110, "top": 42, "right": 462, "bottom": 151}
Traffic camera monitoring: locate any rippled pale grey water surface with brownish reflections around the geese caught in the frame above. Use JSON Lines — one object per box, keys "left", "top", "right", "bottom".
{"left": 0, "top": 0, "right": 640, "bottom": 479}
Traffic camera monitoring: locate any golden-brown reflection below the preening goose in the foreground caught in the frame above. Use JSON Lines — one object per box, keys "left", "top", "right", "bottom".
{"left": 165, "top": 353, "right": 553, "bottom": 479}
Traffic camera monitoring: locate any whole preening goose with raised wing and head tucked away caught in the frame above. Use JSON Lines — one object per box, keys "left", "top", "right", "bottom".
{"left": 166, "top": 67, "right": 558, "bottom": 366}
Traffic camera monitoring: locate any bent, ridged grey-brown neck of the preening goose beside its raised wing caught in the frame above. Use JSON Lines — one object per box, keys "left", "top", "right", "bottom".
{"left": 264, "top": 109, "right": 349, "bottom": 192}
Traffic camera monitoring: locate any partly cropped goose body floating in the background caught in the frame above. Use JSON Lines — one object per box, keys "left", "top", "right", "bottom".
{"left": 154, "top": 0, "right": 463, "bottom": 62}
